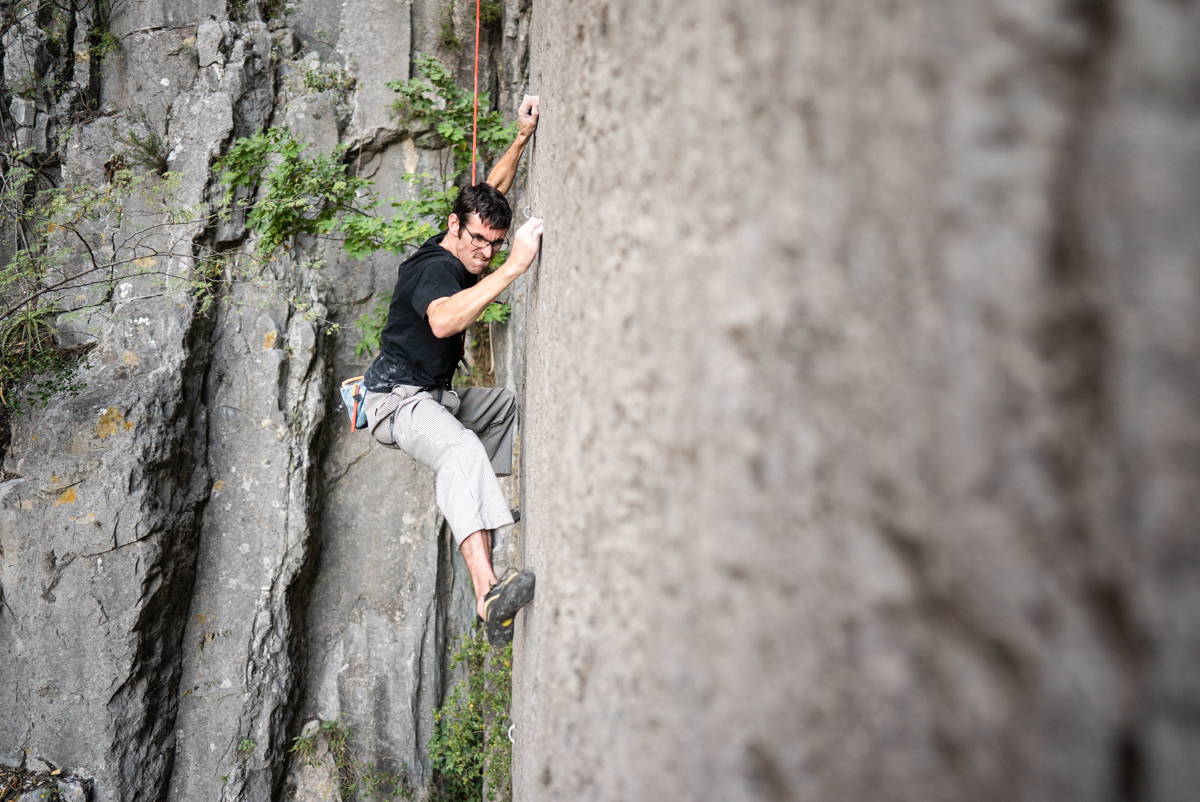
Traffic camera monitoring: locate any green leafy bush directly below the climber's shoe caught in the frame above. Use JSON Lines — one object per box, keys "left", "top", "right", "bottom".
{"left": 430, "top": 630, "right": 512, "bottom": 802}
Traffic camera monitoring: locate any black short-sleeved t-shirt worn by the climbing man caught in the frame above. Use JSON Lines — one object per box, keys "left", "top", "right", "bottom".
{"left": 362, "top": 232, "right": 479, "bottom": 393}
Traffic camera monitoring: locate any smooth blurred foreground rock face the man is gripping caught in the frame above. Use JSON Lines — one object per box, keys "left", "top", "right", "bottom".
{"left": 514, "top": 0, "right": 1200, "bottom": 802}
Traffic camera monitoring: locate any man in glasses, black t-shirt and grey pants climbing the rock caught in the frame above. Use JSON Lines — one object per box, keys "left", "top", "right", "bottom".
{"left": 364, "top": 95, "right": 541, "bottom": 647}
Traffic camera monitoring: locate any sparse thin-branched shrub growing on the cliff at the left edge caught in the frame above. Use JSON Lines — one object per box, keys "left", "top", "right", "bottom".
{"left": 0, "top": 134, "right": 333, "bottom": 417}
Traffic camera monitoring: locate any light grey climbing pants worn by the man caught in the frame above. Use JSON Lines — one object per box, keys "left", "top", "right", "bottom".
{"left": 364, "top": 385, "right": 517, "bottom": 546}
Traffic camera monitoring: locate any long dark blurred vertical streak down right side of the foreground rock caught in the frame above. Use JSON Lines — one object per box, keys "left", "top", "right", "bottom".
{"left": 1037, "top": 0, "right": 1148, "bottom": 758}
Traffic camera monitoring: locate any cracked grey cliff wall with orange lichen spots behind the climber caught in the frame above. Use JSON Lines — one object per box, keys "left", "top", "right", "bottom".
{"left": 0, "top": 0, "right": 528, "bottom": 802}
